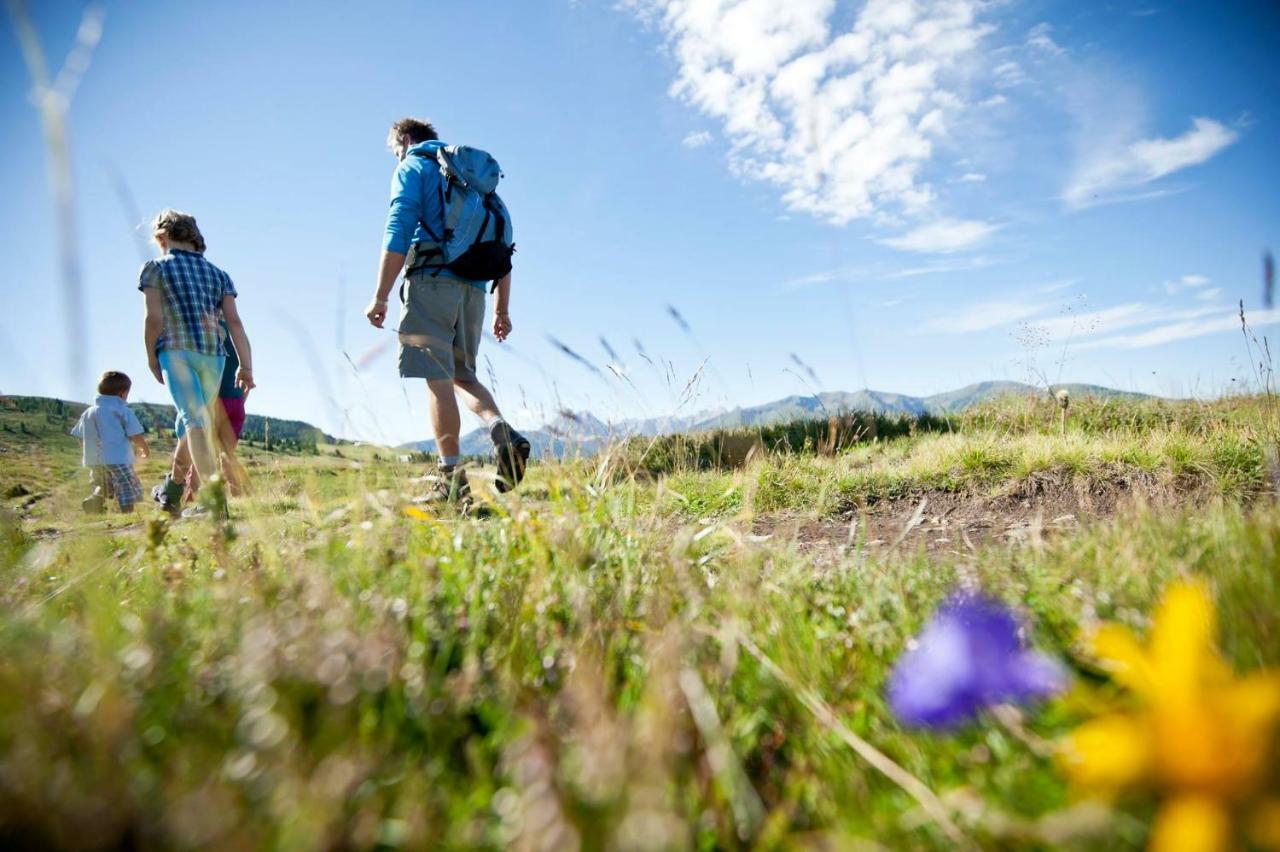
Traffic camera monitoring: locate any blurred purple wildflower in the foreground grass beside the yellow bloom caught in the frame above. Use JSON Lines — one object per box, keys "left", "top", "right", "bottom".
{"left": 888, "top": 594, "right": 1066, "bottom": 728}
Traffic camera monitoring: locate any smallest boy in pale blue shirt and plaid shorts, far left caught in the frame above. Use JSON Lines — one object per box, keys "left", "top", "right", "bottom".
{"left": 72, "top": 370, "right": 148, "bottom": 513}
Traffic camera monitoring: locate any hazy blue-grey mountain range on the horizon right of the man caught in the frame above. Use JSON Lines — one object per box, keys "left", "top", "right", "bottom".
{"left": 401, "top": 381, "right": 1146, "bottom": 458}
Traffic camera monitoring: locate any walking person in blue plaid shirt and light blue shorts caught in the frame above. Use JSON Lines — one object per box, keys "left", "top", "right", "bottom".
{"left": 138, "top": 210, "right": 253, "bottom": 514}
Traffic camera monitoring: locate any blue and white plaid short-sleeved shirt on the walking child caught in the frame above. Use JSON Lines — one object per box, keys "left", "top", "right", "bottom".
{"left": 138, "top": 248, "right": 236, "bottom": 356}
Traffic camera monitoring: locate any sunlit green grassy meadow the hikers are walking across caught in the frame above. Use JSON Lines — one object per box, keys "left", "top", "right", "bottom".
{"left": 0, "top": 398, "right": 1280, "bottom": 849}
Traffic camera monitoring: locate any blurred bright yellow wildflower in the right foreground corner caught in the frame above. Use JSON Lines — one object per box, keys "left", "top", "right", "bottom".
{"left": 1062, "top": 581, "right": 1280, "bottom": 851}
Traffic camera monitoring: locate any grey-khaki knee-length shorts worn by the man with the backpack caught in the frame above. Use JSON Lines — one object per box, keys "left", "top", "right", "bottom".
{"left": 399, "top": 272, "right": 485, "bottom": 381}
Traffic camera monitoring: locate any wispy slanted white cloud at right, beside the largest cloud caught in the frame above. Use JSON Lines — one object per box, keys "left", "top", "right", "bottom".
{"left": 1062, "top": 118, "right": 1239, "bottom": 209}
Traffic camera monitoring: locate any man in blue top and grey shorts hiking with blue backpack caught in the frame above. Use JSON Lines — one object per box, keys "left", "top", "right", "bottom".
{"left": 365, "top": 118, "right": 530, "bottom": 507}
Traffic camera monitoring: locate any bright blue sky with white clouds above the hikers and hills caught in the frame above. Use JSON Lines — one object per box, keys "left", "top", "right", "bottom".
{"left": 0, "top": 0, "right": 1280, "bottom": 441}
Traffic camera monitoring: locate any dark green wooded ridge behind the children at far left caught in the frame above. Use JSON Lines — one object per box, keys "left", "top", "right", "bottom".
{"left": 0, "top": 395, "right": 343, "bottom": 453}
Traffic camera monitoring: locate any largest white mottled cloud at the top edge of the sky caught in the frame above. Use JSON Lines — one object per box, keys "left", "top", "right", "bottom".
{"left": 623, "top": 0, "right": 989, "bottom": 224}
